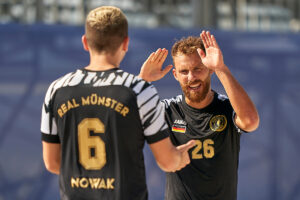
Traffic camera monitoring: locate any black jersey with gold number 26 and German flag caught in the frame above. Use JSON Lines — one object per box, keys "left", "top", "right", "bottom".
{"left": 162, "top": 93, "right": 240, "bottom": 200}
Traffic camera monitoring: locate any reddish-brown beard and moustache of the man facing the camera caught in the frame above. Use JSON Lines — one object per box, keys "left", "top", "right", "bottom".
{"left": 180, "top": 76, "right": 210, "bottom": 103}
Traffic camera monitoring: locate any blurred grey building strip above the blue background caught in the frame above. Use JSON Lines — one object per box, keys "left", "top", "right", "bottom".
{"left": 0, "top": 0, "right": 300, "bottom": 32}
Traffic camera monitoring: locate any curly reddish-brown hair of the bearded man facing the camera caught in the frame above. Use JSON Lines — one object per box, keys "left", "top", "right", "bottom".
{"left": 171, "top": 36, "right": 205, "bottom": 57}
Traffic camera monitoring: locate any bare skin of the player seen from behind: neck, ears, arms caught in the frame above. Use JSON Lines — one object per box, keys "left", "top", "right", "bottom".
{"left": 42, "top": 35, "right": 195, "bottom": 174}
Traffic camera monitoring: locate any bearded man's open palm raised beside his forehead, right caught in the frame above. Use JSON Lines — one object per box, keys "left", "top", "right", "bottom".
{"left": 197, "top": 31, "right": 225, "bottom": 71}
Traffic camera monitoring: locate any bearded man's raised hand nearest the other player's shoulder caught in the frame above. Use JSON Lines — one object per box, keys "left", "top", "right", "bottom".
{"left": 139, "top": 48, "right": 173, "bottom": 82}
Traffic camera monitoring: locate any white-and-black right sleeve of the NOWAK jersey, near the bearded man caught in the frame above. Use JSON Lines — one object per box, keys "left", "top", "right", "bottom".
{"left": 137, "top": 83, "right": 169, "bottom": 144}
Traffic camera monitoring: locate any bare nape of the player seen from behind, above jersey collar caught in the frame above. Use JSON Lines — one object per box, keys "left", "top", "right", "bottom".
{"left": 85, "top": 54, "right": 120, "bottom": 71}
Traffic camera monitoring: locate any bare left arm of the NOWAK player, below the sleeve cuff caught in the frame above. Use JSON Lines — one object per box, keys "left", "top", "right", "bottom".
{"left": 43, "top": 142, "right": 61, "bottom": 174}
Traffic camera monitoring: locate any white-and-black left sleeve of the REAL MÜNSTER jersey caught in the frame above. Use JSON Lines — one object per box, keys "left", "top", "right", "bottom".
{"left": 41, "top": 82, "right": 60, "bottom": 143}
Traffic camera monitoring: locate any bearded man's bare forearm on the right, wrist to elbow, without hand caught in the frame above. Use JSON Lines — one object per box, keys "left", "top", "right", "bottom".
{"left": 215, "top": 66, "right": 259, "bottom": 131}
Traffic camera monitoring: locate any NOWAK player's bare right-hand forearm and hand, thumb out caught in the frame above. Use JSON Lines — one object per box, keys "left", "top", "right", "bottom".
{"left": 149, "top": 137, "right": 195, "bottom": 172}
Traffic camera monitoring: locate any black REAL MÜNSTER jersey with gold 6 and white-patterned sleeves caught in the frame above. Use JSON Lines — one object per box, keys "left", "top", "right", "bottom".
{"left": 41, "top": 69, "right": 169, "bottom": 200}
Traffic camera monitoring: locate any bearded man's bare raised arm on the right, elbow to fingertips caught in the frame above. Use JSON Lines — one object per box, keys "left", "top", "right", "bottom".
{"left": 198, "top": 31, "right": 259, "bottom": 132}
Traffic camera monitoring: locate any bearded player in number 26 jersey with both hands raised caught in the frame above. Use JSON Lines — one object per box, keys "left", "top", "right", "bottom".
{"left": 139, "top": 31, "right": 259, "bottom": 200}
